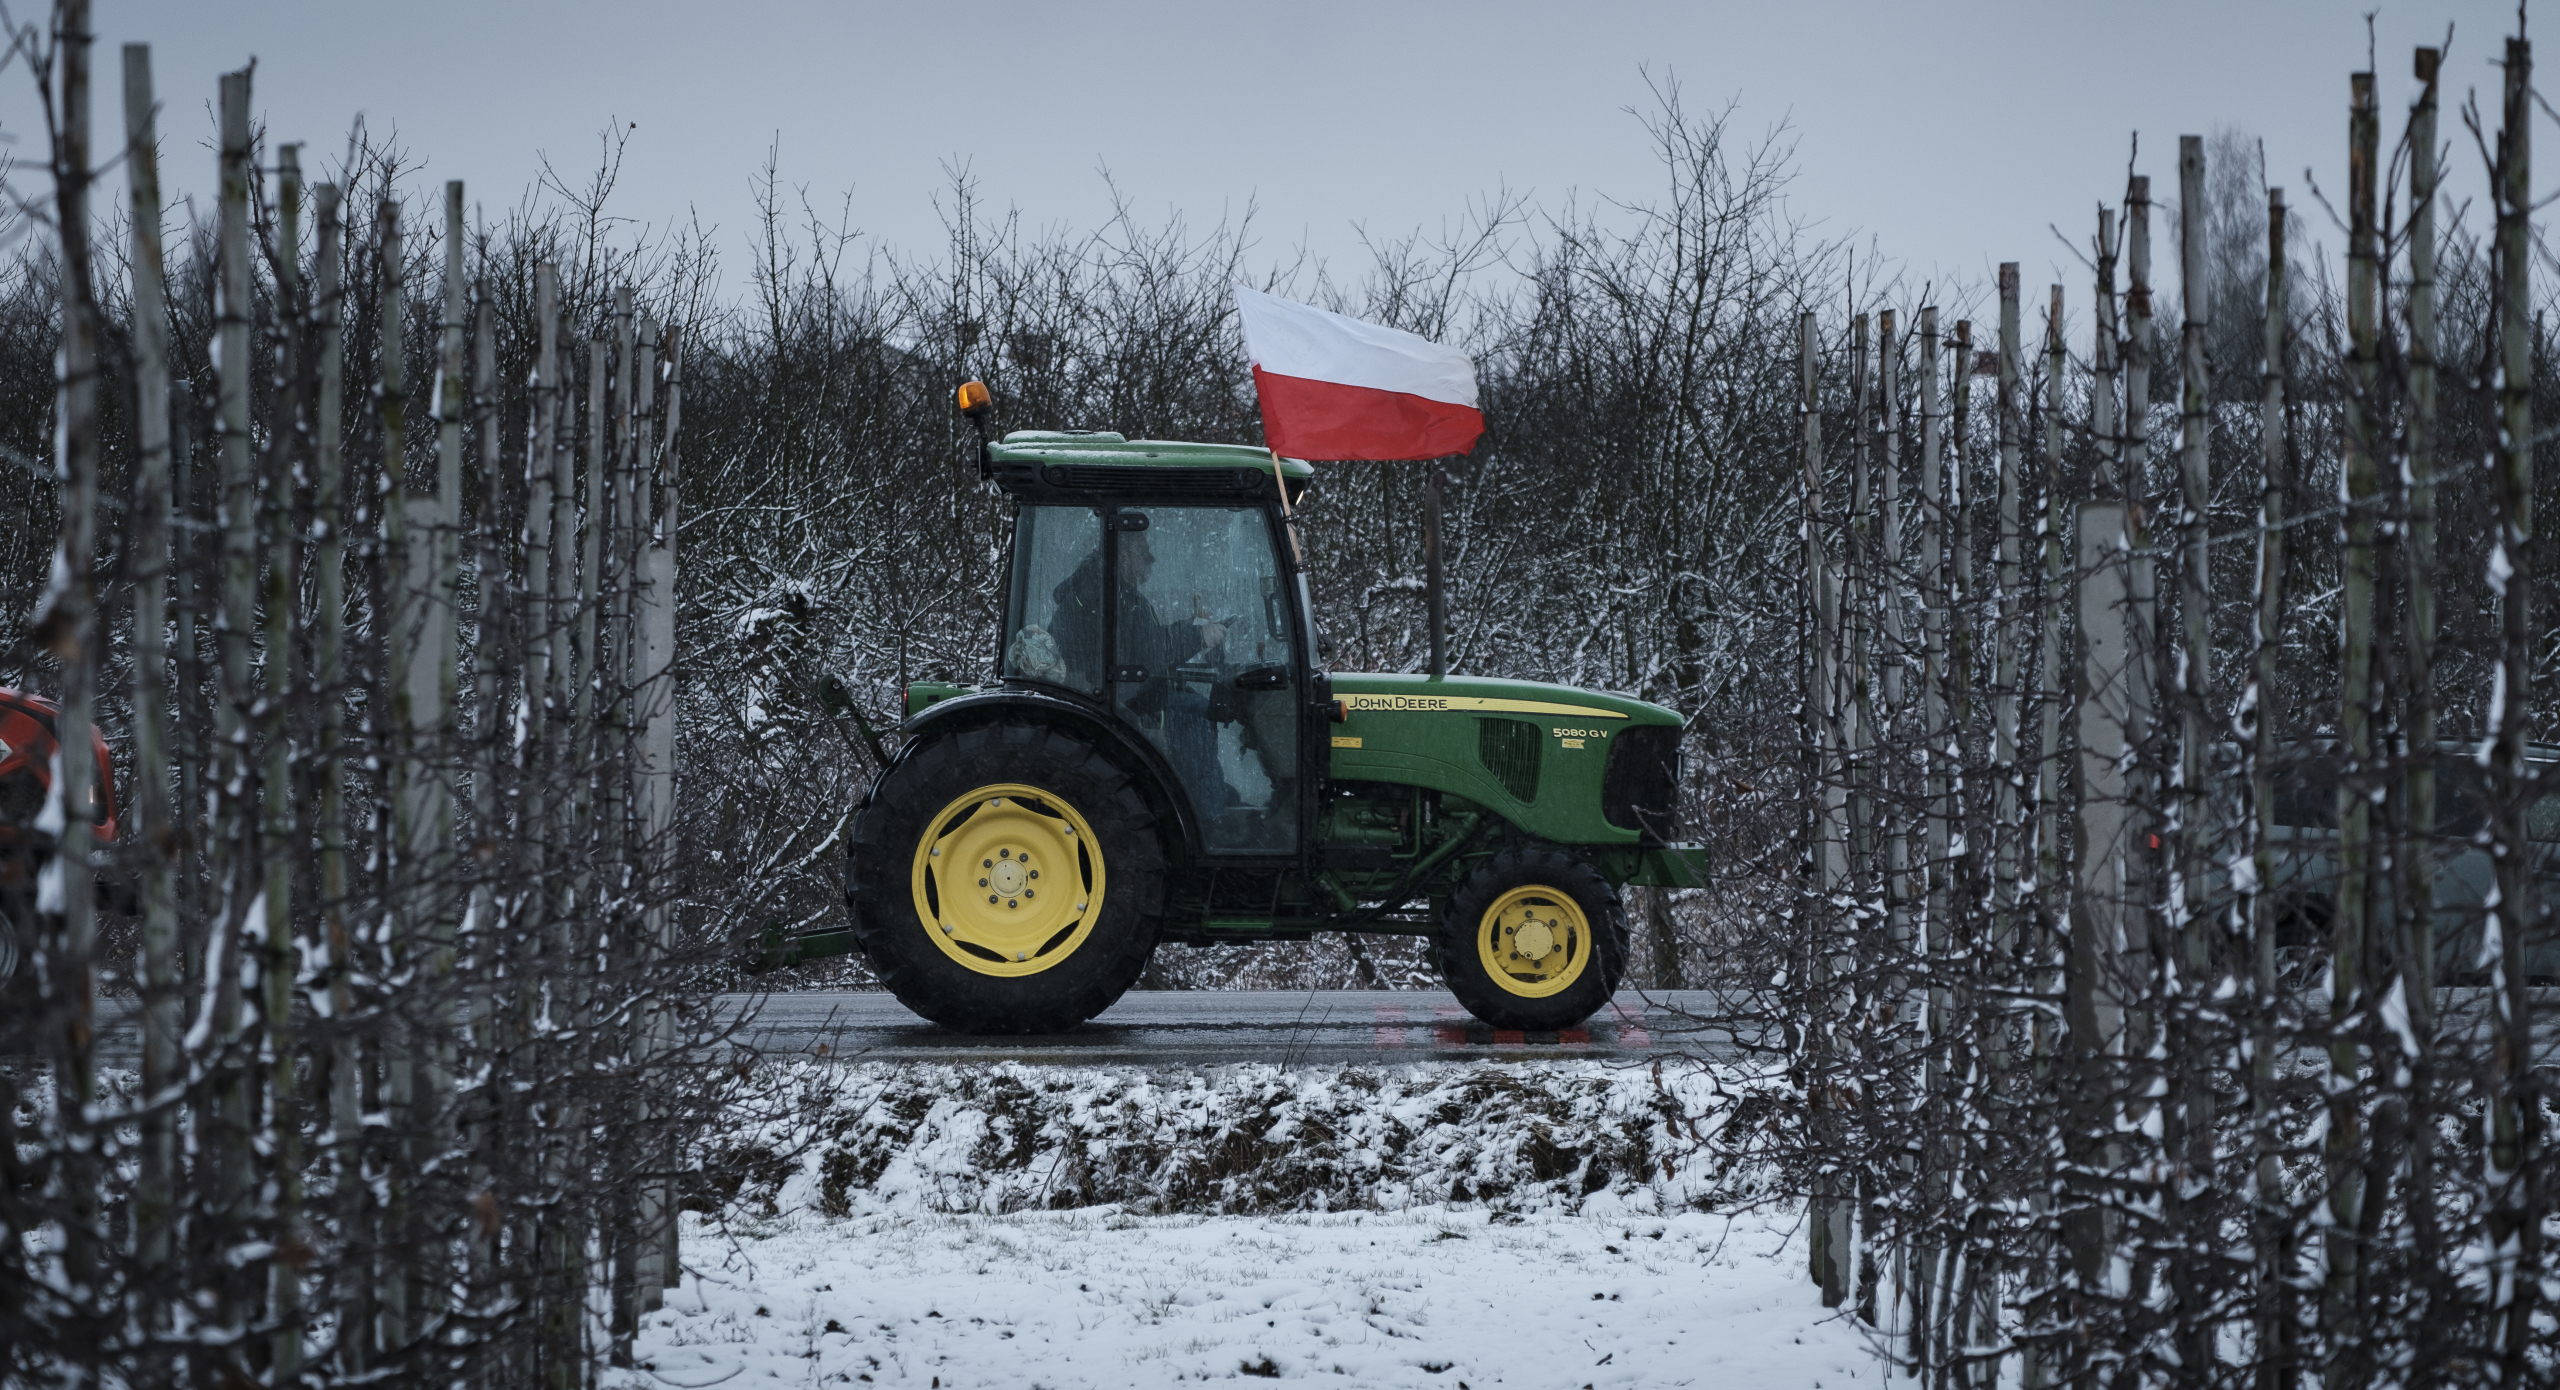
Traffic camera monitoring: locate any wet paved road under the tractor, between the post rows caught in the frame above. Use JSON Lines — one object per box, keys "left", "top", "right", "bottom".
{"left": 722, "top": 991, "right": 1733, "bottom": 1065}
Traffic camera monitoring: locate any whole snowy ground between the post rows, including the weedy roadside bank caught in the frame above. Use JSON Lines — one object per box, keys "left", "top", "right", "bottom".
{"left": 617, "top": 1065, "right": 1882, "bottom": 1390}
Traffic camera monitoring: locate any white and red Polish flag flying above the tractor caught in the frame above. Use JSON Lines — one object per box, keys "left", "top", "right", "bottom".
{"left": 1236, "top": 284, "right": 1485, "bottom": 461}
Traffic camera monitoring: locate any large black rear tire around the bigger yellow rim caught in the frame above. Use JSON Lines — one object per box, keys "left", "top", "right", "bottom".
{"left": 845, "top": 722, "right": 1165, "bottom": 1034}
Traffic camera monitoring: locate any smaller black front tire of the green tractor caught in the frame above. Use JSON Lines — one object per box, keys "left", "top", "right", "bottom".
{"left": 1434, "top": 845, "right": 1628, "bottom": 1032}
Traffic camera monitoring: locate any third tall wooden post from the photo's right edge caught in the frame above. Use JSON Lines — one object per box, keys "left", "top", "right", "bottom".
{"left": 2319, "top": 72, "right": 2381, "bottom": 1354}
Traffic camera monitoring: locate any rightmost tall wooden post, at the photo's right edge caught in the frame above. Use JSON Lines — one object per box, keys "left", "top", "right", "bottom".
{"left": 2483, "top": 38, "right": 2542, "bottom": 1385}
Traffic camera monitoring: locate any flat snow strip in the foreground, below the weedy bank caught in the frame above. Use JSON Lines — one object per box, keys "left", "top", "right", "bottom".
{"left": 622, "top": 1208, "right": 1884, "bottom": 1390}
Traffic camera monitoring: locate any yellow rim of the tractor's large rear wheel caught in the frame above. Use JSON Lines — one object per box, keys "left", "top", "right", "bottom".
{"left": 911, "top": 783, "right": 1103, "bottom": 975}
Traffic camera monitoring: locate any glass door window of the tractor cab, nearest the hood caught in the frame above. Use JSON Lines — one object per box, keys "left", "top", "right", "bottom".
{"left": 1111, "top": 507, "right": 1298, "bottom": 855}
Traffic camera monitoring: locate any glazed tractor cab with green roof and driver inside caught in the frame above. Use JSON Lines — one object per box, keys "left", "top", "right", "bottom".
{"left": 986, "top": 433, "right": 1324, "bottom": 860}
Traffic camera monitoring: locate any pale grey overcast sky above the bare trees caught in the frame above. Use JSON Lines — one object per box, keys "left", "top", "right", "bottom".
{"left": 0, "top": 0, "right": 2560, "bottom": 332}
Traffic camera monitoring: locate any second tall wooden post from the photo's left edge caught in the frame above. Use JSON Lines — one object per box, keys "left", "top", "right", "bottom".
{"left": 125, "top": 44, "right": 184, "bottom": 1305}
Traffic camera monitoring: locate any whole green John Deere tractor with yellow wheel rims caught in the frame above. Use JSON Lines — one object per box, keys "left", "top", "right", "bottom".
{"left": 771, "top": 384, "right": 1702, "bottom": 1032}
